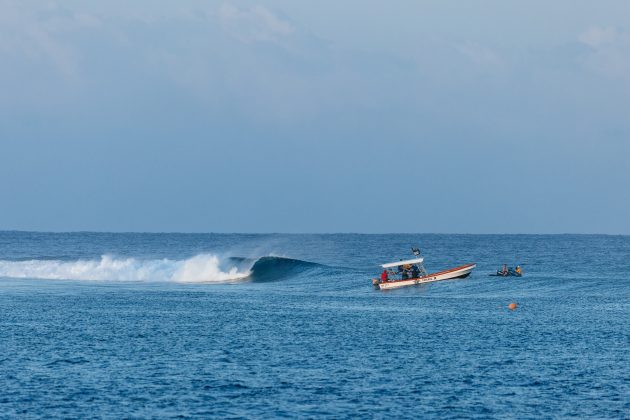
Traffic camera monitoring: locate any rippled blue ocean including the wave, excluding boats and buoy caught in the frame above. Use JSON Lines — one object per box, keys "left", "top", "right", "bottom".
{"left": 0, "top": 232, "right": 630, "bottom": 419}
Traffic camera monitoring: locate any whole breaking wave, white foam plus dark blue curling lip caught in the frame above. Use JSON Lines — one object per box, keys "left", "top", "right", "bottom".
{"left": 0, "top": 254, "right": 326, "bottom": 283}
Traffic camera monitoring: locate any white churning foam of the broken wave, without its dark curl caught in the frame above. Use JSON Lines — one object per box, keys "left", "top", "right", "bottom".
{"left": 0, "top": 254, "right": 251, "bottom": 283}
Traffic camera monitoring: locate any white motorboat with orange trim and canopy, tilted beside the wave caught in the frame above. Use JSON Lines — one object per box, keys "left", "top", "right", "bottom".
{"left": 372, "top": 248, "right": 477, "bottom": 290}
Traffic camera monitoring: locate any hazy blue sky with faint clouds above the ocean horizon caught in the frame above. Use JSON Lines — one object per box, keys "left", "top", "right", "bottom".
{"left": 0, "top": 0, "right": 630, "bottom": 234}
